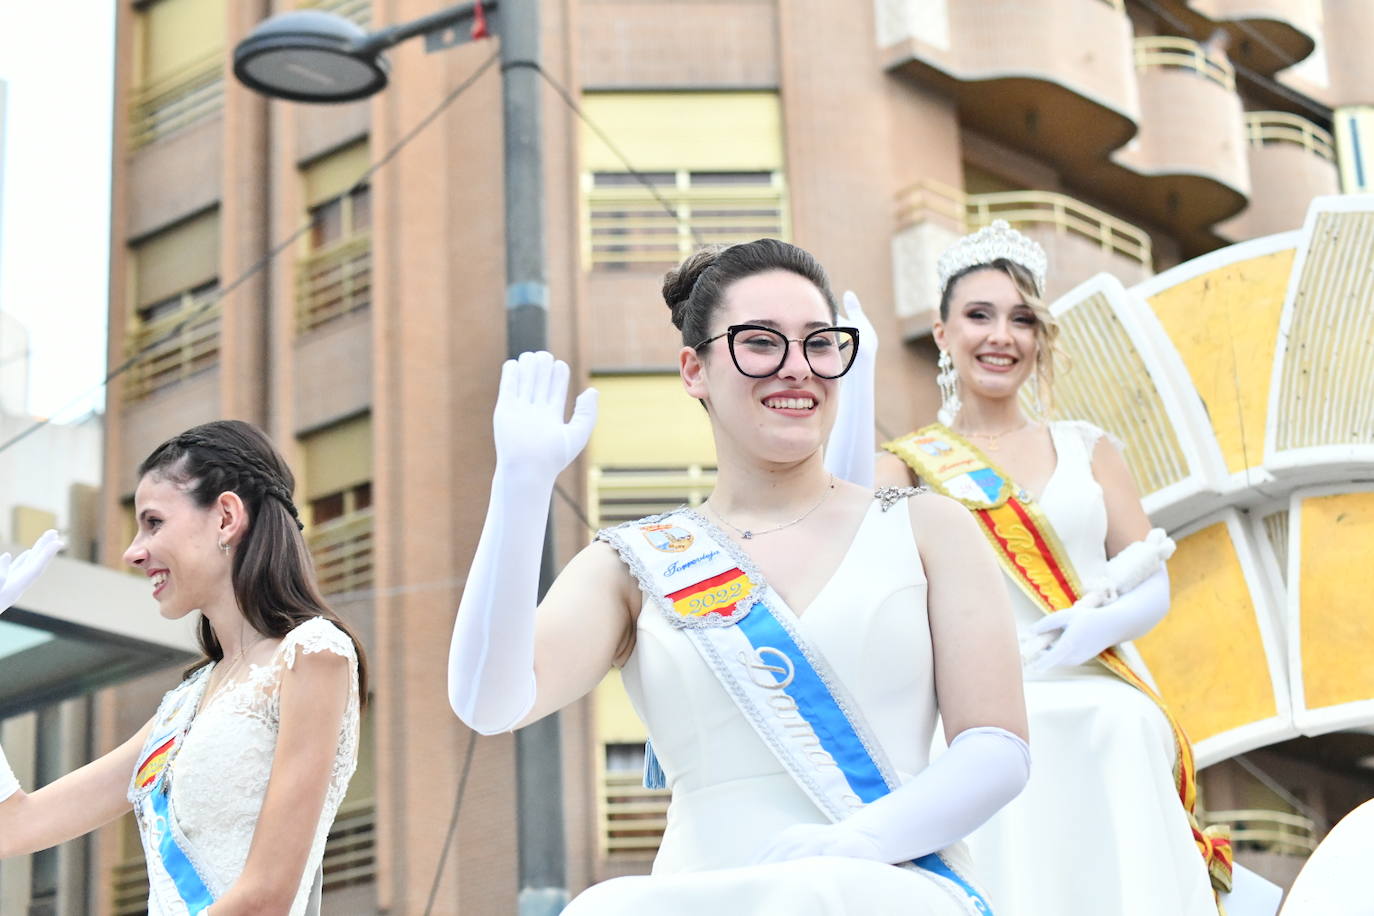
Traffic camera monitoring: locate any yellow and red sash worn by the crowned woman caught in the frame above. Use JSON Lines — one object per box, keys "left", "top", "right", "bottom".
{"left": 882, "top": 423, "right": 1232, "bottom": 891}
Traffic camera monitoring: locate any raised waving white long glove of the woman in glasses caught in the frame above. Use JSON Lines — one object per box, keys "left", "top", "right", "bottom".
{"left": 448, "top": 353, "right": 596, "bottom": 735}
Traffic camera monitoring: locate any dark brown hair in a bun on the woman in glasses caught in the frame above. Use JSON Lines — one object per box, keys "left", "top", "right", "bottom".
{"left": 664, "top": 239, "right": 838, "bottom": 346}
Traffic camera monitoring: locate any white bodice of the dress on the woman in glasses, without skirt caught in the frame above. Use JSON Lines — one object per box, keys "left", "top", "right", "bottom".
{"left": 622, "top": 501, "right": 936, "bottom": 875}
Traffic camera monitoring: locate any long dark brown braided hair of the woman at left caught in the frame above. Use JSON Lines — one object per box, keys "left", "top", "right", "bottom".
{"left": 139, "top": 420, "right": 367, "bottom": 698}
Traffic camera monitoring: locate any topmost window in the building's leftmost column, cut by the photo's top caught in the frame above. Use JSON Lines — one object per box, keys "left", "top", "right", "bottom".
{"left": 129, "top": 0, "right": 228, "bottom": 148}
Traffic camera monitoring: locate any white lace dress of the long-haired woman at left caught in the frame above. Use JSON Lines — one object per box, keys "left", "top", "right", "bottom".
{"left": 129, "top": 617, "right": 359, "bottom": 916}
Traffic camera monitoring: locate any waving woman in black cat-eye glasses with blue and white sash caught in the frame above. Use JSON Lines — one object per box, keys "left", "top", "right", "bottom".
{"left": 448, "top": 239, "right": 1029, "bottom": 916}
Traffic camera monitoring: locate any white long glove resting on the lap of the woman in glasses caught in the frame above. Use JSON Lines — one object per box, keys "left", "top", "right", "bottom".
{"left": 758, "top": 725, "right": 1031, "bottom": 865}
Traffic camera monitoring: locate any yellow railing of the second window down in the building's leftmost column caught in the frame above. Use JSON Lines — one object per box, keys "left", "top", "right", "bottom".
{"left": 125, "top": 291, "right": 220, "bottom": 401}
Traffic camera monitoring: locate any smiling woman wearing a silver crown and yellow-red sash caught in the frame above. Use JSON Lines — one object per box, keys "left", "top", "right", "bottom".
{"left": 851, "top": 221, "right": 1231, "bottom": 916}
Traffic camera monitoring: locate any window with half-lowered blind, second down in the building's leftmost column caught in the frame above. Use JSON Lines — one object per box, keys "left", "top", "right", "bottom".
{"left": 124, "top": 210, "right": 220, "bottom": 401}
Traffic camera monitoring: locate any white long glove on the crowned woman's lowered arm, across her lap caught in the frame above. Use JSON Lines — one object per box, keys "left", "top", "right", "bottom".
{"left": 1025, "top": 563, "right": 1169, "bottom": 674}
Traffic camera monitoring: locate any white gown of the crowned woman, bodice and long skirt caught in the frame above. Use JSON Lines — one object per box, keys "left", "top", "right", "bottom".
{"left": 969, "top": 422, "right": 1217, "bottom": 916}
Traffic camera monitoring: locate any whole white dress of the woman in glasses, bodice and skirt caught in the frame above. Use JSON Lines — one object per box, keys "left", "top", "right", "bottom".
{"left": 565, "top": 503, "right": 996, "bottom": 916}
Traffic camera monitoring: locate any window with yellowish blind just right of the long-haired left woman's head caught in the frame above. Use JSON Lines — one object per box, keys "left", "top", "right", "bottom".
{"left": 301, "top": 416, "right": 372, "bottom": 595}
